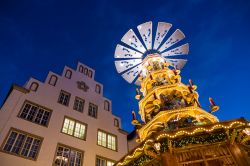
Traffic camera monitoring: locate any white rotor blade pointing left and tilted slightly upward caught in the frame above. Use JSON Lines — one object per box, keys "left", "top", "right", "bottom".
{"left": 115, "top": 44, "right": 142, "bottom": 58}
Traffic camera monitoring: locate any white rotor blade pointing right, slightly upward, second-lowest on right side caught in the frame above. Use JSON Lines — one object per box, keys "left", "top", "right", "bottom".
{"left": 161, "top": 43, "right": 189, "bottom": 57}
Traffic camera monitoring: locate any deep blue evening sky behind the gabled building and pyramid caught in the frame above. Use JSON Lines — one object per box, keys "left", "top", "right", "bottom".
{"left": 0, "top": 0, "right": 250, "bottom": 131}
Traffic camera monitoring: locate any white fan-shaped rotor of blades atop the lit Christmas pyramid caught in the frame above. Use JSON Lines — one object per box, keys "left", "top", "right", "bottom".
{"left": 114, "top": 21, "right": 189, "bottom": 84}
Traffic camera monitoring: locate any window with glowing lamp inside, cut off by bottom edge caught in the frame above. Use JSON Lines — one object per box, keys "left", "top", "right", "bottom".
{"left": 53, "top": 144, "right": 83, "bottom": 166}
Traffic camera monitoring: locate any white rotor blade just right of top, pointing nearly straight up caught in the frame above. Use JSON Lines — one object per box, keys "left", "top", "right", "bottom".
{"left": 154, "top": 22, "right": 172, "bottom": 50}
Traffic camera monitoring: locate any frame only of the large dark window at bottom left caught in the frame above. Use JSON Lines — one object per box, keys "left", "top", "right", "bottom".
{"left": 0, "top": 127, "right": 44, "bottom": 161}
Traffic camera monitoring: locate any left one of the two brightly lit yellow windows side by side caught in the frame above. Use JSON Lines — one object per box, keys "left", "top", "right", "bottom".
{"left": 62, "top": 118, "right": 87, "bottom": 140}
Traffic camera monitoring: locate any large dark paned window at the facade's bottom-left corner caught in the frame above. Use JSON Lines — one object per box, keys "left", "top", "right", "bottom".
{"left": 2, "top": 129, "right": 42, "bottom": 160}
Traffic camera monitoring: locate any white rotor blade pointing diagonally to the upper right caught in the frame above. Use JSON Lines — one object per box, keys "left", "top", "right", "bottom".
{"left": 159, "top": 29, "right": 185, "bottom": 52}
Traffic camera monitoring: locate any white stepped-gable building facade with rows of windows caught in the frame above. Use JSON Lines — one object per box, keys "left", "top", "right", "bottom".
{"left": 0, "top": 63, "right": 128, "bottom": 166}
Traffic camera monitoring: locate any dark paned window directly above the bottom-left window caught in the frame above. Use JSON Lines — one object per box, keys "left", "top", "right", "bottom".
{"left": 19, "top": 101, "right": 51, "bottom": 126}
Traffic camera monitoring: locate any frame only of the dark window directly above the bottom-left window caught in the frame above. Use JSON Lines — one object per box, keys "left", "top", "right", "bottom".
{"left": 17, "top": 100, "right": 53, "bottom": 127}
